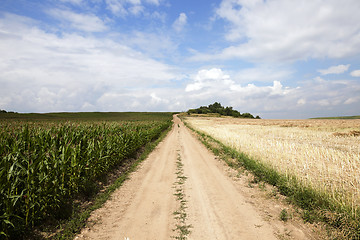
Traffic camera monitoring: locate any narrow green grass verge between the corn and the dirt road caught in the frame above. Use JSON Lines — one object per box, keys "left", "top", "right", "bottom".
{"left": 52, "top": 122, "right": 172, "bottom": 240}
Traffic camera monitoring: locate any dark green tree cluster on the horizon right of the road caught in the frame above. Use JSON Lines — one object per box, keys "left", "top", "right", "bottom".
{"left": 187, "top": 102, "right": 260, "bottom": 119}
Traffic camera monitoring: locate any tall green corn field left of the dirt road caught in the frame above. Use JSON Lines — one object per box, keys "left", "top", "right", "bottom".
{"left": 0, "top": 113, "right": 172, "bottom": 238}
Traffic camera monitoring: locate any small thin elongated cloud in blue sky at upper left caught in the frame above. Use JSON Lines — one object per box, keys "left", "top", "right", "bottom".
{"left": 49, "top": 9, "right": 107, "bottom": 32}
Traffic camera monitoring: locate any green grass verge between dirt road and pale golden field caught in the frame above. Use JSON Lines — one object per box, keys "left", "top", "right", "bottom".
{"left": 183, "top": 121, "right": 360, "bottom": 240}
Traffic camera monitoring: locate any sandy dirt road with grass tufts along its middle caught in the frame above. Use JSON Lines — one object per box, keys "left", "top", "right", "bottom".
{"left": 75, "top": 116, "right": 311, "bottom": 240}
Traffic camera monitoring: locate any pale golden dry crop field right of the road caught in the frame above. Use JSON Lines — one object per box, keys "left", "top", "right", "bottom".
{"left": 186, "top": 117, "right": 360, "bottom": 222}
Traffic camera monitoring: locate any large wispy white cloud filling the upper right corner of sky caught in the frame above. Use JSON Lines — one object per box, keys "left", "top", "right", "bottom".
{"left": 207, "top": 0, "right": 360, "bottom": 62}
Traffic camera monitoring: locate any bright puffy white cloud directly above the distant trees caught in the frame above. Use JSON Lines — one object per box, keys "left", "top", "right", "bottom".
{"left": 186, "top": 68, "right": 299, "bottom": 113}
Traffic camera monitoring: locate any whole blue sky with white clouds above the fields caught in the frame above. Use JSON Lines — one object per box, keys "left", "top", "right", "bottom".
{"left": 0, "top": 0, "right": 360, "bottom": 119}
